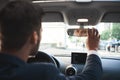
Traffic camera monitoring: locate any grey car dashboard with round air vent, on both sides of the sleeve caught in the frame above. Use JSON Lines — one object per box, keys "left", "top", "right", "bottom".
{"left": 55, "top": 53, "right": 120, "bottom": 80}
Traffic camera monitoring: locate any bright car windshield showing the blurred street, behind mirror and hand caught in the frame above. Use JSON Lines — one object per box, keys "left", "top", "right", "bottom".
{"left": 39, "top": 22, "right": 120, "bottom": 58}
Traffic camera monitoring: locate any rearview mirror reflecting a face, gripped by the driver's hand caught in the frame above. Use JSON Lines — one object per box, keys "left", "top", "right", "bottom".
{"left": 67, "top": 28, "right": 88, "bottom": 37}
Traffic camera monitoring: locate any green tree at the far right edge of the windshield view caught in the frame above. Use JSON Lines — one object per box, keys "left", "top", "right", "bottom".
{"left": 111, "top": 23, "right": 120, "bottom": 40}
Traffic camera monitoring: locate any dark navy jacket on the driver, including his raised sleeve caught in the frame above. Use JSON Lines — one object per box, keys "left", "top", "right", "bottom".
{"left": 0, "top": 53, "right": 102, "bottom": 80}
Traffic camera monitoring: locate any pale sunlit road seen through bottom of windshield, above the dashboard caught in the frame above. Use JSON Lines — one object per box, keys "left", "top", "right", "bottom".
{"left": 41, "top": 47, "right": 120, "bottom": 58}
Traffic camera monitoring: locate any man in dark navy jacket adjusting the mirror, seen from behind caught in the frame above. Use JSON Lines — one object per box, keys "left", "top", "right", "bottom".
{"left": 0, "top": 1, "right": 102, "bottom": 80}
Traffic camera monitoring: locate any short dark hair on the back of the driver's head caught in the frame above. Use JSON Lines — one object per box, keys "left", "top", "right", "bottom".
{"left": 0, "top": 1, "right": 43, "bottom": 50}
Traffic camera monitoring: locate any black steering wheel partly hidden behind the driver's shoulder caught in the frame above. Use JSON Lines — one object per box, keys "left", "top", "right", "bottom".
{"left": 27, "top": 51, "right": 58, "bottom": 67}
